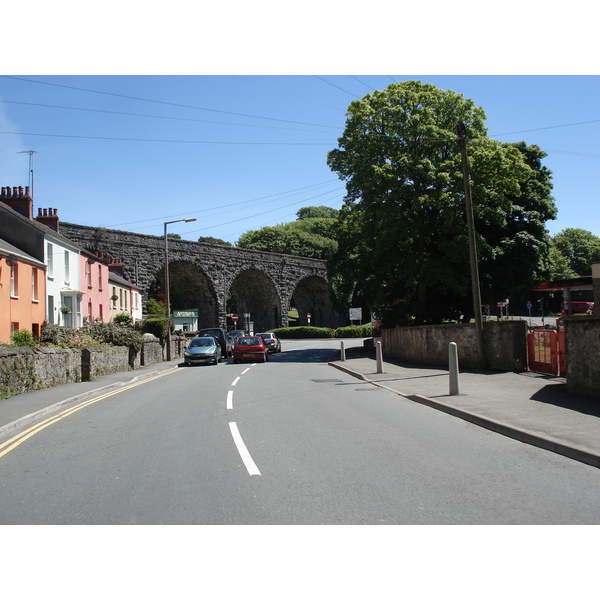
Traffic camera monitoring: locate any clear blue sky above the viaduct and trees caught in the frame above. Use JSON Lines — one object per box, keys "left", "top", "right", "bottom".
{"left": 0, "top": 73, "right": 600, "bottom": 243}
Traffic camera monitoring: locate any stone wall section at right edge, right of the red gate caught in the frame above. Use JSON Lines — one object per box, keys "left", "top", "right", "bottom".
{"left": 564, "top": 315, "right": 600, "bottom": 399}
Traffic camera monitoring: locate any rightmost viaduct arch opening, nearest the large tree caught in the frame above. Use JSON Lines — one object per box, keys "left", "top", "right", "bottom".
{"left": 291, "top": 275, "right": 340, "bottom": 327}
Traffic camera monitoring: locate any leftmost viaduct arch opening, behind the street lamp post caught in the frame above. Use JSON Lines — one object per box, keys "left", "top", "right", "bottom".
{"left": 148, "top": 260, "right": 221, "bottom": 328}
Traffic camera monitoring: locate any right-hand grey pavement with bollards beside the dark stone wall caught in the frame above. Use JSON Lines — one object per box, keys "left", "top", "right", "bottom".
{"left": 329, "top": 349, "right": 600, "bottom": 467}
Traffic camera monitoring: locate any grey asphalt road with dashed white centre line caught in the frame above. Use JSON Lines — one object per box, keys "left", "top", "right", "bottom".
{"left": 0, "top": 340, "right": 600, "bottom": 524}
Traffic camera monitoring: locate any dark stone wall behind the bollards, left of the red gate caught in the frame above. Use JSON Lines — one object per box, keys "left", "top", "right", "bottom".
{"left": 381, "top": 321, "right": 527, "bottom": 371}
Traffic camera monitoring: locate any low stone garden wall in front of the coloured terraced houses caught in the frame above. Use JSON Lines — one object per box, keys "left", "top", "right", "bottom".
{"left": 0, "top": 336, "right": 186, "bottom": 401}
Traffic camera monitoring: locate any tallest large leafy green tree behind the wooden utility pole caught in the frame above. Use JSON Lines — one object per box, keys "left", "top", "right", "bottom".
{"left": 328, "top": 81, "right": 553, "bottom": 325}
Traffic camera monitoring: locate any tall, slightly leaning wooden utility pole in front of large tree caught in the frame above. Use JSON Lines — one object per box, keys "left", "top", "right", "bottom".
{"left": 457, "top": 121, "right": 486, "bottom": 368}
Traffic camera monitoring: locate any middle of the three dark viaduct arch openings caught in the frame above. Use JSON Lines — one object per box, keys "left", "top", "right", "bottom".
{"left": 229, "top": 267, "right": 287, "bottom": 332}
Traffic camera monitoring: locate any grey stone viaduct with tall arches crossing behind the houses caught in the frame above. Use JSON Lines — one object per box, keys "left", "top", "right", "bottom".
{"left": 60, "top": 221, "right": 345, "bottom": 331}
